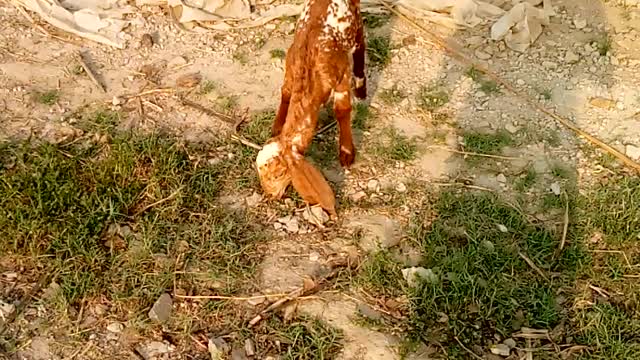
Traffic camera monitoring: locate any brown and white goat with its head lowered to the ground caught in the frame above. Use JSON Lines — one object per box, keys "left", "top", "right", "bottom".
{"left": 256, "top": 0, "right": 367, "bottom": 217}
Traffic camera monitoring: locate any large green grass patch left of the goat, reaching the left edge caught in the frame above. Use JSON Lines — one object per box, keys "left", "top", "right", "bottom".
{"left": 0, "top": 128, "right": 263, "bottom": 312}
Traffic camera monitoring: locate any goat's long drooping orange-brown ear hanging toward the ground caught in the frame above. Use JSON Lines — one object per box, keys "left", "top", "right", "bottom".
{"left": 290, "top": 158, "right": 338, "bottom": 219}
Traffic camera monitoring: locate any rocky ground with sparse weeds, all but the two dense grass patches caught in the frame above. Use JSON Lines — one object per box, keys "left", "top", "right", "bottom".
{"left": 0, "top": 1, "right": 640, "bottom": 359}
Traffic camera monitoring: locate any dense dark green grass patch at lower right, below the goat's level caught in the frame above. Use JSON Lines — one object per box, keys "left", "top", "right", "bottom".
{"left": 409, "top": 192, "right": 586, "bottom": 346}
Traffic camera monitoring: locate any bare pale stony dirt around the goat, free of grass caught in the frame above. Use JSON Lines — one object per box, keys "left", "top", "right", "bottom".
{"left": 0, "top": 0, "right": 640, "bottom": 360}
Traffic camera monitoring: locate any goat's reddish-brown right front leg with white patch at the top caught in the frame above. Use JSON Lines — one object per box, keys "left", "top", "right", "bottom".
{"left": 333, "top": 76, "right": 356, "bottom": 168}
